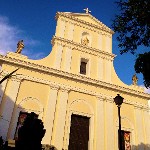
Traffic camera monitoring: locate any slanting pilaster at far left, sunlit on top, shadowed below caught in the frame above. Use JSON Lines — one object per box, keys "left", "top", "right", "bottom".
{"left": 0, "top": 79, "right": 20, "bottom": 139}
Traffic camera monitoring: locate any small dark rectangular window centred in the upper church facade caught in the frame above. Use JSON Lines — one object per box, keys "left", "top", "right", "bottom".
{"left": 80, "top": 58, "right": 88, "bottom": 75}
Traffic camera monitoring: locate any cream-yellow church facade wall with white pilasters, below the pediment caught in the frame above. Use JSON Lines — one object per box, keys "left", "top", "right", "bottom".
{"left": 0, "top": 11, "right": 150, "bottom": 150}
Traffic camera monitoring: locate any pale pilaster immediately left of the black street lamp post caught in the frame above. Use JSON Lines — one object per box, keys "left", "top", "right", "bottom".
{"left": 105, "top": 98, "right": 115, "bottom": 150}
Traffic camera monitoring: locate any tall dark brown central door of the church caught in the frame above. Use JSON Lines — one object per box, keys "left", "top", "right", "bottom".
{"left": 69, "top": 115, "right": 89, "bottom": 150}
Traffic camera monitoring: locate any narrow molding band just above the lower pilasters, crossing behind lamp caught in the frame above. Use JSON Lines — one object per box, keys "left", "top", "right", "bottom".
{"left": 0, "top": 70, "right": 150, "bottom": 111}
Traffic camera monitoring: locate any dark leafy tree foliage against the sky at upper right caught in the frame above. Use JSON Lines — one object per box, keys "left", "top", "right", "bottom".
{"left": 112, "top": 0, "right": 150, "bottom": 87}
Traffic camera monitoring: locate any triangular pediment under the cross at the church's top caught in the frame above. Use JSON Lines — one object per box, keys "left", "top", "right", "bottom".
{"left": 58, "top": 12, "right": 114, "bottom": 34}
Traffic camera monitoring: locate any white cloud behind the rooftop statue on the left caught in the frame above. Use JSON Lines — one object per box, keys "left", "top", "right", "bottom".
{"left": 0, "top": 16, "right": 41, "bottom": 59}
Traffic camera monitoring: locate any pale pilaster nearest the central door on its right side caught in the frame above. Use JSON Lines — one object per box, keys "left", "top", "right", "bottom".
{"left": 96, "top": 97, "right": 105, "bottom": 150}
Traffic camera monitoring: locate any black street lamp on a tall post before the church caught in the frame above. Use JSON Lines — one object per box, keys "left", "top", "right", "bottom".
{"left": 114, "top": 94, "right": 124, "bottom": 150}
